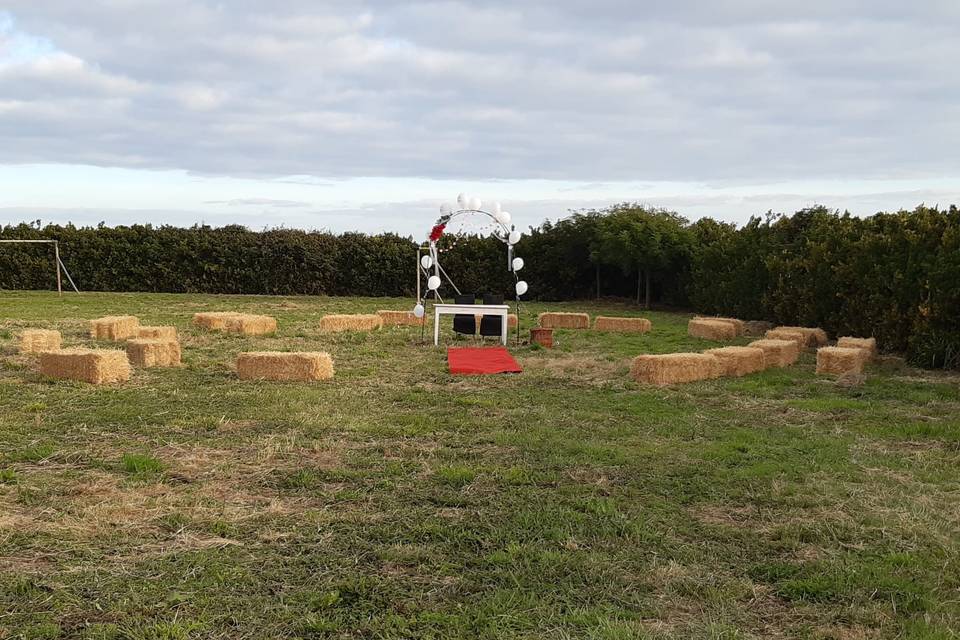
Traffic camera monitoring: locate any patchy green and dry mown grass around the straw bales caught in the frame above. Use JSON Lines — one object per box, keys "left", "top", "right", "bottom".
{"left": 0, "top": 292, "right": 960, "bottom": 640}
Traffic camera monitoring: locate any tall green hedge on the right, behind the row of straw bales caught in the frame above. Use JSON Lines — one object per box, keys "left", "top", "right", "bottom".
{"left": 687, "top": 206, "right": 960, "bottom": 368}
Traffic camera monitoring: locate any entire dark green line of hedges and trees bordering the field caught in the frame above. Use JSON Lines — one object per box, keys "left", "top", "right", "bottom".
{"left": 0, "top": 203, "right": 960, "bottom": 368}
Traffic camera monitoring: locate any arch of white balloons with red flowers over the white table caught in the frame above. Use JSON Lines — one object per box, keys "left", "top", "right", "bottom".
{"left": 413, "top": 193, "right": 528, "bottom": 318}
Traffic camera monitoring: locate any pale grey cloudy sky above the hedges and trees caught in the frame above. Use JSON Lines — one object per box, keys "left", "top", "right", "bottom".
{"left": 0, "top": 0, "right": 960, "bottom": 236}
